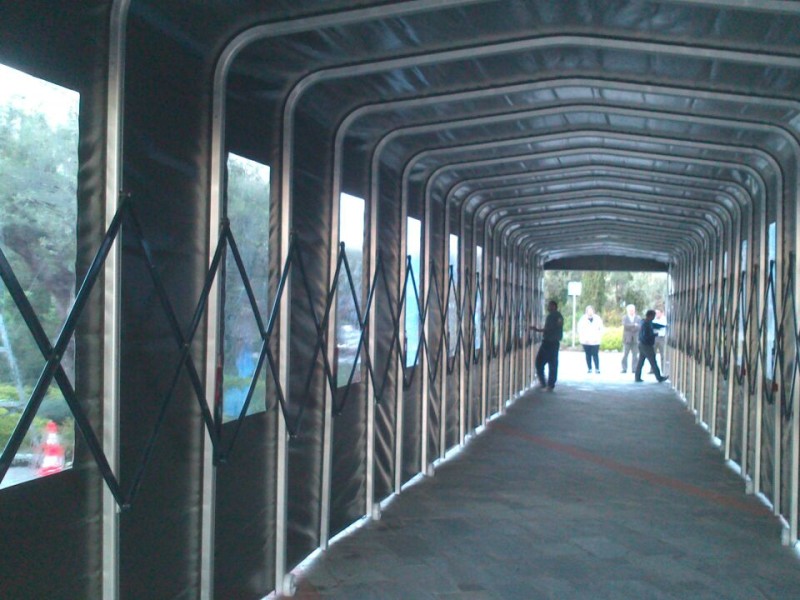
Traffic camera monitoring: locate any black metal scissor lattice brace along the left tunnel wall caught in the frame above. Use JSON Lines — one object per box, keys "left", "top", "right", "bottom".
{"left": 0, "top": 194, "right": 506, "bottom": 509}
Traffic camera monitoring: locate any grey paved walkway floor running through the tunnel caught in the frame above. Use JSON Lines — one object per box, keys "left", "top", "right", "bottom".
{"left": 282, "top": 353, "right": 800, "bottom": 600}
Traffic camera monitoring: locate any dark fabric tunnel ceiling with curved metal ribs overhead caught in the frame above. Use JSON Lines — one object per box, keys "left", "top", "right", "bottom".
{"left": 142, "top": 0, "right": 800, "bottom": 268}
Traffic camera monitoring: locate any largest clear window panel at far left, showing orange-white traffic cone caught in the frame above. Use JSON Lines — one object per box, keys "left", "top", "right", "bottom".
{"left": 0, "top": 65, "right": 80, "bottom": 487}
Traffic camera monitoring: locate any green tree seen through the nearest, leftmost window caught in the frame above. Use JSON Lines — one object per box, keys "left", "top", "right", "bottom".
{"left": 0, "top": 95, "right": 78, "bottom": 382}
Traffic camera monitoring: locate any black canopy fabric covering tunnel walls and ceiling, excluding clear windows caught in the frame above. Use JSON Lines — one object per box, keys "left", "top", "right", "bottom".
{"left": 0, "top": 0, "right": 800, "bottom": 598}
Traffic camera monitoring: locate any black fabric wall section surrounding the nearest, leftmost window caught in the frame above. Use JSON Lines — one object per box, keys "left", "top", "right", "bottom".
{"left": 0, "top": 0, "right": 108, "bottom": 598}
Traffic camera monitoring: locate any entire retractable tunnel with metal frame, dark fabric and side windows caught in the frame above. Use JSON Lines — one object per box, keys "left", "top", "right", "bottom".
{"left": 0, "top": 0, "right": 800, "bottom": 598}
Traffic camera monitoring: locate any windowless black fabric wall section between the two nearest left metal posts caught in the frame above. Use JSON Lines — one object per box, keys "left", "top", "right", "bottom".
{"left": 120, "top": 7, "right": 210, "bottom": 598}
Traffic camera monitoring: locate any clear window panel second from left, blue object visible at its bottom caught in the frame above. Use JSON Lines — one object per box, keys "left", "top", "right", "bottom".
{"left": 222, "top": 154, "right": 270, "bottom": 421}
